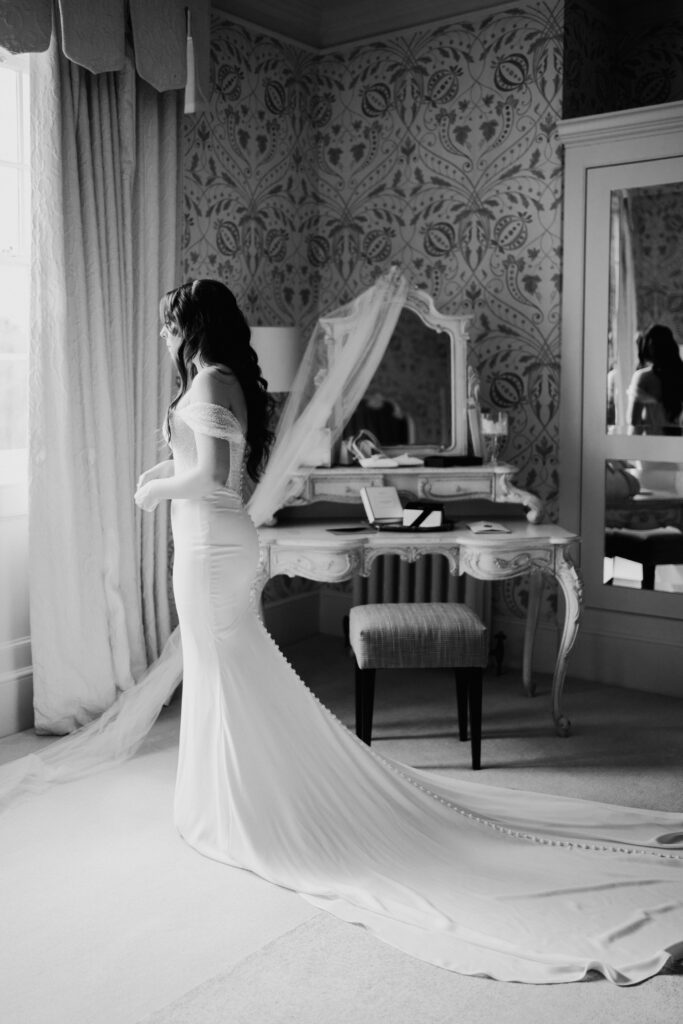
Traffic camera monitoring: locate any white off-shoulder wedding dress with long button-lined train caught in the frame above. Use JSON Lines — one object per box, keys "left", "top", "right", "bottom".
{"left": 166, "top": 389, "right": 683, "bottom": 984}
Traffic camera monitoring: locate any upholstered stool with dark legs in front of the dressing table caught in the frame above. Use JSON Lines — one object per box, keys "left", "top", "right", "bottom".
{"left": 349, "top": 601, "right": 488, "bottom": 768}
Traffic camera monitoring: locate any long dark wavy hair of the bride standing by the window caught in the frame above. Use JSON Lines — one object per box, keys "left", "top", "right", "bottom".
{"left": 159, "top": 279, "right": 274, "bottom": 480}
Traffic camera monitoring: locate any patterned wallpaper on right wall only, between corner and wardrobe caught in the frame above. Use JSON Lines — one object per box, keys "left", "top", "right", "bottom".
{"left": 309, "top": 3, "right": 562, "bottom": 502}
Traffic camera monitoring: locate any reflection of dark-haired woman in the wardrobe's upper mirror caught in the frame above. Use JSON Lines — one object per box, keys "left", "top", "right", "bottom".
{"left": 628, "top": 324, "right": 683, "bottom": 434}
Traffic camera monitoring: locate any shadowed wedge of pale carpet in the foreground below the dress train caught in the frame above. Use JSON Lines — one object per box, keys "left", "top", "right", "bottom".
{"left": 140, "top": 913, "right": 683, "bottom": 1024}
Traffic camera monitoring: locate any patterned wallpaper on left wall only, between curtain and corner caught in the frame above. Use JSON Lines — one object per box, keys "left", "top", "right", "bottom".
{"left": 183, "top": 29, "right": 317, "bottom": 326}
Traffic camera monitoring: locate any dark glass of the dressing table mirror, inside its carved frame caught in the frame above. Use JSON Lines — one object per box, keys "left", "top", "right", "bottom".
{"left": 344, "top": 306, "right": 455, "bottom": 449}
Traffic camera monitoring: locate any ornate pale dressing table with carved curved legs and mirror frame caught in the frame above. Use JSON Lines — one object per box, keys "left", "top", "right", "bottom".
{"left": 258, "top": 280, "right": 582, "bottom": 736}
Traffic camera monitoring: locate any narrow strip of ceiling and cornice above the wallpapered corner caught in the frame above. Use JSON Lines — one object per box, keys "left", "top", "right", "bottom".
{"left": 211, "top": 0, "right": 511, "bottom": 49}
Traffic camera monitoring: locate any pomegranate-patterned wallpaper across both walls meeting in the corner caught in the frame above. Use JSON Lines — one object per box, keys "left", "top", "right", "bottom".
{"left": 184, "top": 0, "right": 563, "bottom": 605}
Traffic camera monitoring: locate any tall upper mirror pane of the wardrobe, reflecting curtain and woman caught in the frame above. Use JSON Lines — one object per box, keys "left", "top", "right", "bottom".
{"left": 607, "top": 182, "right": 683, "bottom": 434}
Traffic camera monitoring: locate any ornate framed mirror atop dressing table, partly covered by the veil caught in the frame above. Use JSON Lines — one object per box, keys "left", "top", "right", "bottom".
{"left": 343, "top": 289, "right": 470, "bottom": 456}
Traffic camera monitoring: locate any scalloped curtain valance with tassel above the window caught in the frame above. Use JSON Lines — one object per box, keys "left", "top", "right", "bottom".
{"left": 0, "top": 0, "right": 210, "bottom": 99}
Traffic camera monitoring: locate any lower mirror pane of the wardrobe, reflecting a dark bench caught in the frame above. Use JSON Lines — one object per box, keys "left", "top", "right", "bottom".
{"left": 603, "top": 460, "right": 683, "bottom": 592}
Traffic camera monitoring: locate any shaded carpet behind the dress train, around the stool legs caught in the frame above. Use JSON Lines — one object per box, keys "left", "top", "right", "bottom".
{"left": 288, "top": 637, "right": 683, "bottom": 811}
